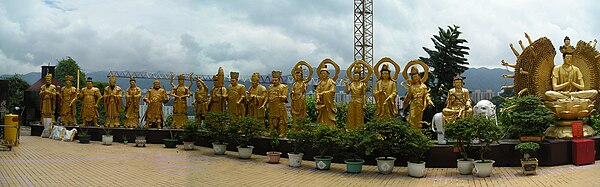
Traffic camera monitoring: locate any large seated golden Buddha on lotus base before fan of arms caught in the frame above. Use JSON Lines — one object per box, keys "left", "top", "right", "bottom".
{"left": 545, "top": 37, "right": 598, "bottom": 119}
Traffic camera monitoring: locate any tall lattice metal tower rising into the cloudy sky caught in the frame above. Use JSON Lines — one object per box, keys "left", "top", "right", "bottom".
{"left": 354, "top": 0, "right": 377, "bottom": 87}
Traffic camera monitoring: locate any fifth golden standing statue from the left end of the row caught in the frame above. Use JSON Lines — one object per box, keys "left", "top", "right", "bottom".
{"left": 125, "top": 77, "right": 142, "bottom": 128}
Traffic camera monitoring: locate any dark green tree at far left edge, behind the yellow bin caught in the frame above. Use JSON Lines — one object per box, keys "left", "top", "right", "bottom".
{"left": 6, "top": 75, "right": 29, "bottom": 113}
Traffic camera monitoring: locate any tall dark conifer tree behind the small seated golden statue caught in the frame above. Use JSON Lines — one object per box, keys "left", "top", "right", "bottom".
{"left": 419, "top": 25, "right": 469, "bottom": 114}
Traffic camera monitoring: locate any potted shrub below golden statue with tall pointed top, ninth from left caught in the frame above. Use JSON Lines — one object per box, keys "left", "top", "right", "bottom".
{"left": 204, "top": 112, "right": 234, "bottom": 155}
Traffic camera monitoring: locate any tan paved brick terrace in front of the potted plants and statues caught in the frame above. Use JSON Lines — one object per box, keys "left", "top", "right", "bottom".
{"left": 0, "top": 136, "right": 600, "bottom": 186}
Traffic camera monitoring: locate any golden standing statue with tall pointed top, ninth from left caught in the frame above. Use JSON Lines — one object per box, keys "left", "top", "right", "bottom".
{"left": 208, "top": 67, "right": 227, "bottom": 112}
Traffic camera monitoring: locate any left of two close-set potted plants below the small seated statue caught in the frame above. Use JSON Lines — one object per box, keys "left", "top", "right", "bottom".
{"left": 446, "top": 117, "right": 479, "bottom": 175}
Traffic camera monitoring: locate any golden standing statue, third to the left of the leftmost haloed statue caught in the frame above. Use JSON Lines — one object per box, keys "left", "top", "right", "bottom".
{"left": 227, "top": 71, "right": 246, "bottom": 117}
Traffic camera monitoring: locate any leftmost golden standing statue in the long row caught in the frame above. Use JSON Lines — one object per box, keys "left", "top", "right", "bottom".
{"left": 40, "top": 73, "right": 58, "bottom": 123}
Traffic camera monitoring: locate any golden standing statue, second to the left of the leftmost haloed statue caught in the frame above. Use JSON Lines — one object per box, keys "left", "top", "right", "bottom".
{"left": 248, "top": 72, "right": 267, "bottom": 120}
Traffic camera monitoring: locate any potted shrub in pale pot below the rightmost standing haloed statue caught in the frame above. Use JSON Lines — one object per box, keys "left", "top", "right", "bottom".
{"left": 401, "top": 128, "right": 432, "bottom": 177}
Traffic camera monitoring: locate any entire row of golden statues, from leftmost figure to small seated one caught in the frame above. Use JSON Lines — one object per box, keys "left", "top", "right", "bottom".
{"left": 40, "top": 58, "right": 472, "bottom": 134}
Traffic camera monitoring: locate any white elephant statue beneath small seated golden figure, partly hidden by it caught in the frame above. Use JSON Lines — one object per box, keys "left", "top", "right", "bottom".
{"left": 431, "top": 100, "right": 498, "bottom": 145}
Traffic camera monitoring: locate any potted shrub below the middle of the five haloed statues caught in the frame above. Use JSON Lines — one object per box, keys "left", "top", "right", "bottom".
{"left": 338, "top": 130, "right": 374, "bottom": 173}
